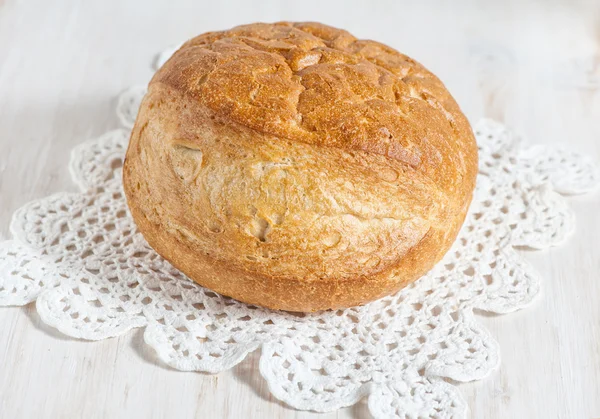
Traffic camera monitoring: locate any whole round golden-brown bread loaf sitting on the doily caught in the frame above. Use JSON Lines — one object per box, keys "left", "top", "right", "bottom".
{"left": 123, "top": 22, "right": 477, "bottom": 312}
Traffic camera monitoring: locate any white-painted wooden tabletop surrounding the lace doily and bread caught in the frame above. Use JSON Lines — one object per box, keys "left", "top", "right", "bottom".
{"left": 0, "top": 0, "right": 600, "bottom": 419}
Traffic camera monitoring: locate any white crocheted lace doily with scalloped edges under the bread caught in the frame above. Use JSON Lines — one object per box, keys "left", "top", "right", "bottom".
{"left": 0, "top": 50, "right": 600, "bottom": 418}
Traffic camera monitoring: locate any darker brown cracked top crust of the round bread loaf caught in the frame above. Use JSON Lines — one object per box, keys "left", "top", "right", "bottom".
{"left": 151, "top": 22, "right": 477, "bottom": 208}
